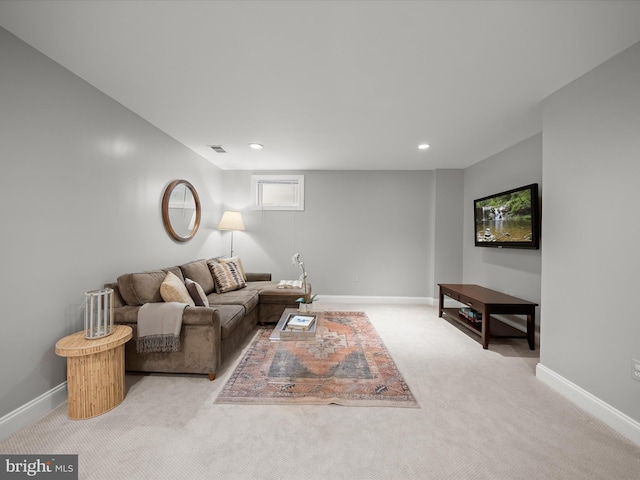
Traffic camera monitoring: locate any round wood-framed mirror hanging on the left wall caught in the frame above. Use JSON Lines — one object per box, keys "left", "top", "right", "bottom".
{"left": 162, "top": 180, "right": 200, "bottom": 242}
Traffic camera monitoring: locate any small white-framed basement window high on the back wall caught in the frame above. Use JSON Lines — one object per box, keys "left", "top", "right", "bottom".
{"left": 251, "top": 175, "right": 304, "bottom": 210}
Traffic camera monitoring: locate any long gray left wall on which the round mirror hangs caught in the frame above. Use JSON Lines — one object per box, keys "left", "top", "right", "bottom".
{"left": 0, "top": 29, "right": 221, "bottom": 417}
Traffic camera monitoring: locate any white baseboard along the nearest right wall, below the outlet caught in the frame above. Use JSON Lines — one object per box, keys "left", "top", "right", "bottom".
{"left": 536, "top": 363, "right": 640, "bottom": 446}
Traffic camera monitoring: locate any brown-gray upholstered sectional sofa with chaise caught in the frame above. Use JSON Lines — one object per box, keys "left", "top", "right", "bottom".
{"left": 105, "top": 259, "right": 311, "bottom": 380}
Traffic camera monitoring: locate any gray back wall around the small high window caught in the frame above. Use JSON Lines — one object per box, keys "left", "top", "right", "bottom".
{"left": 223, "top": 171, "right": 435, "bottom": 298}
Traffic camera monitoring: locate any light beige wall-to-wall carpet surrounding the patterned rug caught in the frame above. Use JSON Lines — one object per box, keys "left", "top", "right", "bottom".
{"left": 0, "top": 305, "right": 640, "bottom": 480}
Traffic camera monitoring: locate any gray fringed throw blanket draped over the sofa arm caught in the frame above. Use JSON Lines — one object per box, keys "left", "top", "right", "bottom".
{"left": 136, "top": 302, "right": 187, "bottom": 353}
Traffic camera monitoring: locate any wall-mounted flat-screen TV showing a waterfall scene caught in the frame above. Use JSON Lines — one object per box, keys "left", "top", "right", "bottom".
{"left": 473, "top": 183, "right": 540, "bottom": 249}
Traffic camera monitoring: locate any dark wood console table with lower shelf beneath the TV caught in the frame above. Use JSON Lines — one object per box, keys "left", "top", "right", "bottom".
{"left": 438, "top": 283, "right": 538, "bottom": 350}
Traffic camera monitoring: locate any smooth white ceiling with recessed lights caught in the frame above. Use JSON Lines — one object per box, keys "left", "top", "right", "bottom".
{"left": 0, "top": 0, "right": 640, "bottom": 170}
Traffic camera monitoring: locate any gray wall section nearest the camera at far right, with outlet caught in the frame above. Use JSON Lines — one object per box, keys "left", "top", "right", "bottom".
{"left": 540, "top": 44, "right": 640, "bottom": 421}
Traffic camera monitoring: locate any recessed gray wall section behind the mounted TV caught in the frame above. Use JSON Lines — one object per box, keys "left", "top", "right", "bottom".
{"left": 462, "top": 134, "right": 547, "bottom": 324}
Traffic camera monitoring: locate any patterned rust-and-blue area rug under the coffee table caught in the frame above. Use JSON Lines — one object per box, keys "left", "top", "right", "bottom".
{"left": 215, "top": 312, "right": 419, "bottom": 407}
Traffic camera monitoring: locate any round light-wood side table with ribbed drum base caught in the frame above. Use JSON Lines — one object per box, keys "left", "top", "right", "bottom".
{"left": 56, "top": 325, "right": 132, "bottom": 420}
